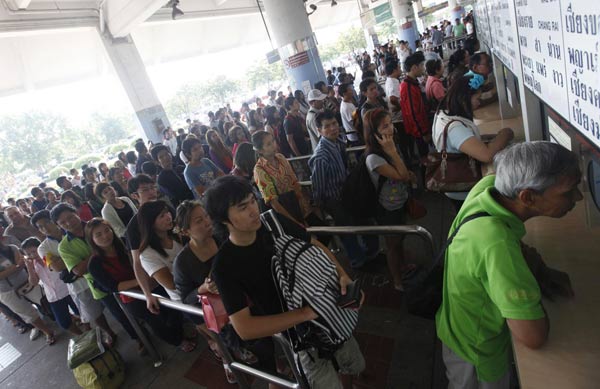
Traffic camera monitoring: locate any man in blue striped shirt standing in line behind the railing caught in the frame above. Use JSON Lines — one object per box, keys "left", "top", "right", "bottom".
{"left": 308, "top": 110, "right": 379, "bottom": 268}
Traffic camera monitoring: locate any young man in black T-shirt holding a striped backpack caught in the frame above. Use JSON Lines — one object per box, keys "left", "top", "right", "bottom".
{"left": 204, "top": 176, "right": 365, "bottom": 388}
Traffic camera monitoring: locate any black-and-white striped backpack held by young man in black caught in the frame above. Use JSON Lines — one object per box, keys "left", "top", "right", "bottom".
{"left": 261, "top": 210, "right": 358, "bottom": 359}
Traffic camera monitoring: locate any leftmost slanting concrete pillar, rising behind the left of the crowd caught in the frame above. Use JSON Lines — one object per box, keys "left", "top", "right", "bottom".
{"left": 100, "top": 30, "right": 170, "bottom": 143}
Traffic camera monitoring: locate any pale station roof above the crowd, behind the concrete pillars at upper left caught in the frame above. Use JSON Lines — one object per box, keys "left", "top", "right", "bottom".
{"left": 0, "top": 0, "right": 359, "bottom": 96}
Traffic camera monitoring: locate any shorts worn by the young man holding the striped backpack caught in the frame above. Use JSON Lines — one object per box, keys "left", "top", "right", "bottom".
{"left": 298, "top": 337, "right": 365, "bottom": 389}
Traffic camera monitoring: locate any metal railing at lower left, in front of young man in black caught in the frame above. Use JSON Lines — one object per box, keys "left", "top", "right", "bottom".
{"left": 115, "top": 290, "right": 309, "bottom": 389}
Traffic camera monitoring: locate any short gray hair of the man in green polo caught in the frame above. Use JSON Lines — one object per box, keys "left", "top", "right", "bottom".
{"left": 494, "top": 141, "right": 581, "bottom": 199}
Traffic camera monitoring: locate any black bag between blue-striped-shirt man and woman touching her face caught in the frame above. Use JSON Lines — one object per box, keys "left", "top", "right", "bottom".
{"left": 341, "top": 153, "right": 386, "bottom": 219}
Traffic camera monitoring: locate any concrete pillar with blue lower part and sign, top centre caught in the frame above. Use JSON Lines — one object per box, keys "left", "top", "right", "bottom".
{"left": 263, "top": 0, "right": 325, "bottom": 94}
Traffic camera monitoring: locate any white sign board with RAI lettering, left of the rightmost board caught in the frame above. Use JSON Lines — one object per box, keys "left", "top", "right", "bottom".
{"left": 515, "top": 0, "right": 569, "bottom": 118}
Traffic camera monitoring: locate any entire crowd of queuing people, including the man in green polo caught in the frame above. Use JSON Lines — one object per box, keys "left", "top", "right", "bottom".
{"left": 0, "top": 9, "right": 581, "bottom": 388}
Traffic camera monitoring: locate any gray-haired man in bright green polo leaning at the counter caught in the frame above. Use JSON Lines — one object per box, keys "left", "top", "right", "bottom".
{"left": 436, "top": 142, "right": 583, "bottom": 388}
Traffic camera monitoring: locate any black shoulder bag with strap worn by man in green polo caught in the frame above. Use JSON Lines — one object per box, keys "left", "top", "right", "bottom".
{"left": 402, "top": 212, "right": 491, "bottom": 320}
